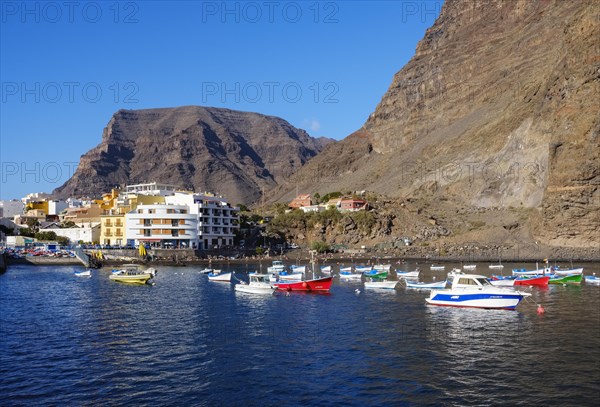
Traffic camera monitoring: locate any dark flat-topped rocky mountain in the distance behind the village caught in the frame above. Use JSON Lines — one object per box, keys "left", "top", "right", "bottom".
{"left": 54, "top": 106, "right": 332, "bottom": 203}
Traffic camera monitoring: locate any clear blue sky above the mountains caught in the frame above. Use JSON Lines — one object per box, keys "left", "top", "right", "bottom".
{"left": 0, "top": 1, "right": 442, "bottom": 199}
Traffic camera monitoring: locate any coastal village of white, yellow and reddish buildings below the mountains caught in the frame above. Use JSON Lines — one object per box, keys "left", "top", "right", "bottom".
{"left": 0, "top": 182, "right": 368, "bottom": 258}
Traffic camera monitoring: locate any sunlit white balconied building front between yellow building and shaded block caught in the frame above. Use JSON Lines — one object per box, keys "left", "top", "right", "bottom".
{"left": 125, "top": 204, "right": 198, "bottom": 249}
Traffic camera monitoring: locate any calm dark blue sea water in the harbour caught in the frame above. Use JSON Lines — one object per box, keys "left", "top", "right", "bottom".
{"left": 0, "top": 263, "right": 600, "bottom": 406}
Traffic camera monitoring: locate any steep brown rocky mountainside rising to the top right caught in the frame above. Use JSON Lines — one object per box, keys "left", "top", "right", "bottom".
{"left": 272, "top": 0, "right": 600, "bottom": 247}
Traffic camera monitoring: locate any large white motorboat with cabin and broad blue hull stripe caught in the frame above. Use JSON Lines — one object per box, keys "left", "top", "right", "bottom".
{"left": 426, "top": 274, "right": 531, "bottom": 309}
